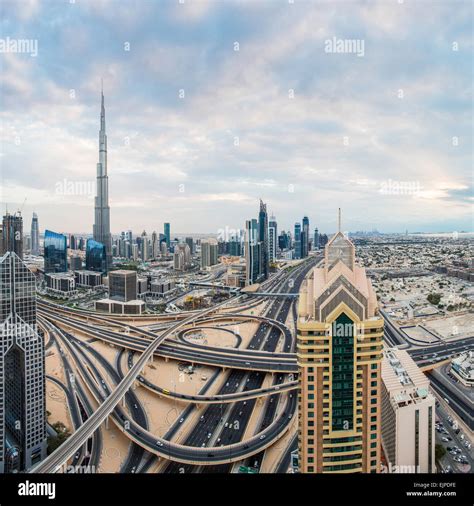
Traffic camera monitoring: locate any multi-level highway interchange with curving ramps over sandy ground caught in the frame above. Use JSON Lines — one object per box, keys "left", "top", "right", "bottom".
{"left": 34, "top": 257, "right": 474, "bottom": 473}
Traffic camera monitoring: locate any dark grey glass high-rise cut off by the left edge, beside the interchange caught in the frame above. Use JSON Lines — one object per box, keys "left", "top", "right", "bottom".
{"left": 0, "top": 251, "right": 47, "bottom": 473}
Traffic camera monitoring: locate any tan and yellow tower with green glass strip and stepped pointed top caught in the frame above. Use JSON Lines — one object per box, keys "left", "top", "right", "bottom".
{"left": 297, "top": 213, "right": 383, "bottom": 473}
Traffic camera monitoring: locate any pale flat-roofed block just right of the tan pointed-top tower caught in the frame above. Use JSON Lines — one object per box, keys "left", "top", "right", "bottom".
{"left": 381, "top": 348, "right": 436, "bottom": 473}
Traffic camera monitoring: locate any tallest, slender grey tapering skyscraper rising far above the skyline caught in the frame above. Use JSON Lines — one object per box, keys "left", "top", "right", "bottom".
{"left": 93, "top": 85, "right": 112, "bottom": 271}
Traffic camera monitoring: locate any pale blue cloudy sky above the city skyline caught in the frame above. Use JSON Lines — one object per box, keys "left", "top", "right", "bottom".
{"left": 0, "top": 0, "right": 473, "bottom": 237}
